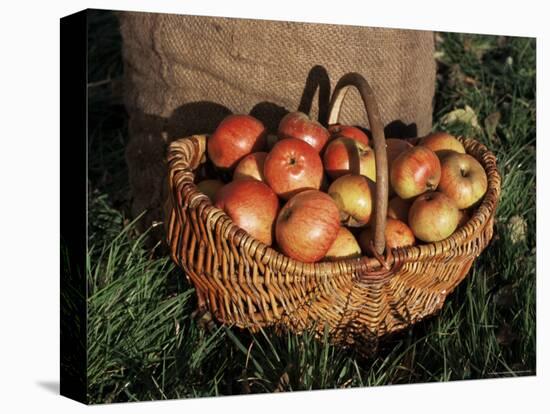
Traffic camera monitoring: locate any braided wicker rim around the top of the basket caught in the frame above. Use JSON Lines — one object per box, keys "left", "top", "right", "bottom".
{"left": 168, "top": 135, "right": 501, "bottom": 281}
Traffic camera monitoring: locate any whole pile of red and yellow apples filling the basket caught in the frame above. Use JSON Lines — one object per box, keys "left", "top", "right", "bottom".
{"left": 197, "top": 112, "right": 487, "bottom": 263}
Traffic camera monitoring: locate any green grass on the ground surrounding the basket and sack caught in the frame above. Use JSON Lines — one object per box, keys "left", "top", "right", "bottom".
{"left": 87, "top": 13, "right": 536, "bottom": 403}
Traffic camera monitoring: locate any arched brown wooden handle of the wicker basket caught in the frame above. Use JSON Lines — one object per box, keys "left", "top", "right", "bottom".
{"left": 328, "top": 72, "right": 388, "bottom": 255}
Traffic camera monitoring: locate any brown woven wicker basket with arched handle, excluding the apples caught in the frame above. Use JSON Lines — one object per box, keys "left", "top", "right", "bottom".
{"left": 166, "top": 73, "right": 500, "bottom": 347}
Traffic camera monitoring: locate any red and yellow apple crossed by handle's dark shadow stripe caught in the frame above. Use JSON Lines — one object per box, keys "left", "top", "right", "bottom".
{"left": 323, "top": 137, "right": 376, "bottom": 181}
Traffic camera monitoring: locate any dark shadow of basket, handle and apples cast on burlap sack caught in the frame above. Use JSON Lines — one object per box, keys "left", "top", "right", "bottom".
{"left": 126, "top": 65, "right": 417, "bottom": 240}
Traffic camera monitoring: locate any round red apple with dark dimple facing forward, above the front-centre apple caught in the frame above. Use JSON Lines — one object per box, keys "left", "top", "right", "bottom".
{"left": 264, "top": 138, "right": 323, "bottom": 200}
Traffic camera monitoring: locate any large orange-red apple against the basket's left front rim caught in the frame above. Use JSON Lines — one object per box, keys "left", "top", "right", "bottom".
{"left": 214, "top": 180, "right": 279, "bottom": 246}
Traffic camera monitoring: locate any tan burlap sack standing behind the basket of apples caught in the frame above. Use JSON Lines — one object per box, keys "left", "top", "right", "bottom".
{"left": 119, "top": 12, "right": 435, "bottom": 234}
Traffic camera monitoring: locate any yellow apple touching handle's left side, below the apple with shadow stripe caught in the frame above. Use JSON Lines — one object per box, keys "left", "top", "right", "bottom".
{"left": 327, "top": 175, "right": 374, "bottom": 227}
